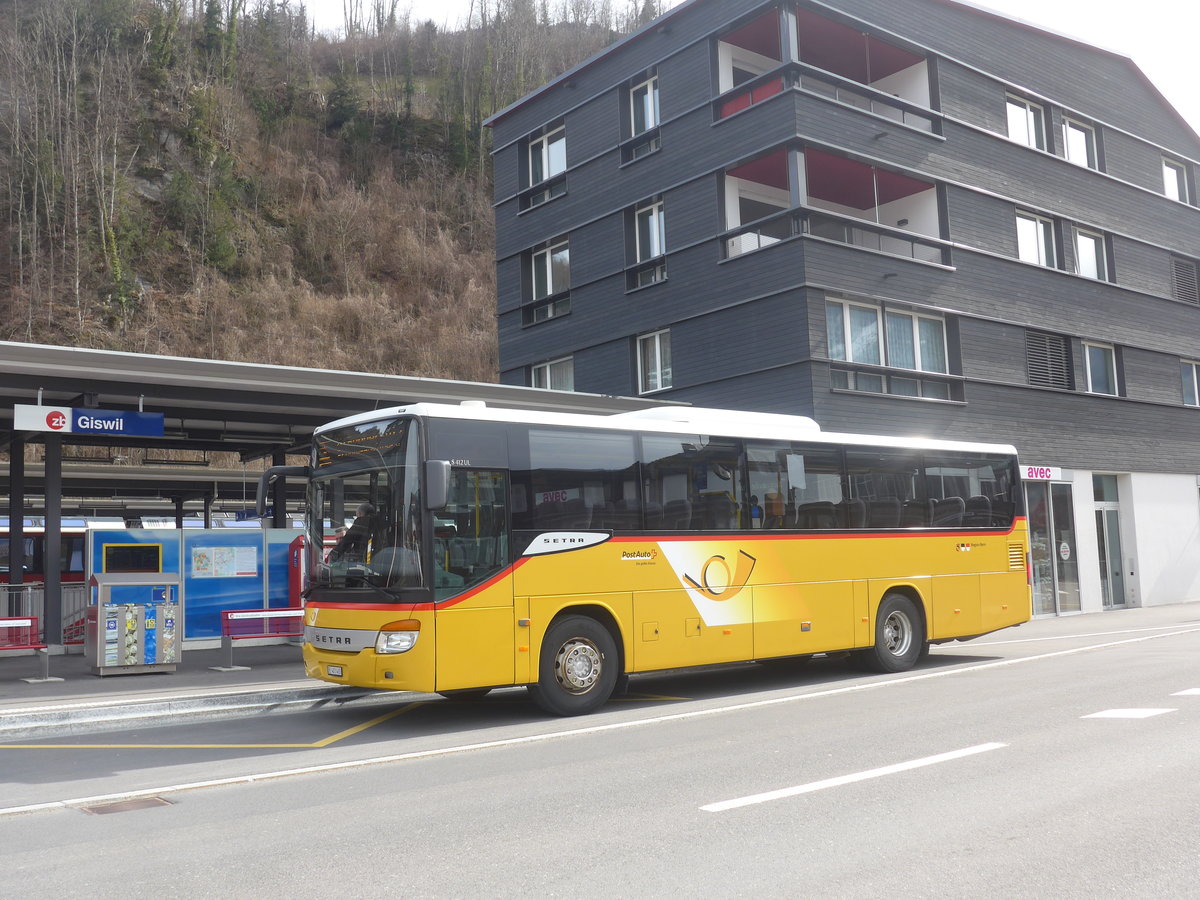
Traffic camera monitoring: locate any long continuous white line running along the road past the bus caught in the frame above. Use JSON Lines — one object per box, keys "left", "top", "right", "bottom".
{"left": 0, "top": 628, "right": 1200, "bottom": 816}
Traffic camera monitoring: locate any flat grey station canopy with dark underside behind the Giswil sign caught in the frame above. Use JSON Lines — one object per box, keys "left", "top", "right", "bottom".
{"left": 0, "top": 342, "right": 664, "bottom": 518}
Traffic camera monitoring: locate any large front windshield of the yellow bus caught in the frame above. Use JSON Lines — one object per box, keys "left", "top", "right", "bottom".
{"left": 308, "top": 419, "right": 425, "bottom": 602}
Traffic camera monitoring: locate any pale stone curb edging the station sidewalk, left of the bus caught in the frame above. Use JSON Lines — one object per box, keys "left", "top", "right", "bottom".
{"left": 0, "top": 686, "right": 396, "bottom": 742}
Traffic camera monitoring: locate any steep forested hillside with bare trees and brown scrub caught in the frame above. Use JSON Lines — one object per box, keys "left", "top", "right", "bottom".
{"left": 0, "top": 0, "right": 654, "bottom": 380}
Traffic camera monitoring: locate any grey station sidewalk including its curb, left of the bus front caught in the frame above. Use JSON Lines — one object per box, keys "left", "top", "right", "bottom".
{"left": 0, "top": 644, "right": 389, "bottom": 742}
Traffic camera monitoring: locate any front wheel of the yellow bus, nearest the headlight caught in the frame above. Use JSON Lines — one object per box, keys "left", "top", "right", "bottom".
{"left": 529, "top": 616, "right": 620, "bottom": 715}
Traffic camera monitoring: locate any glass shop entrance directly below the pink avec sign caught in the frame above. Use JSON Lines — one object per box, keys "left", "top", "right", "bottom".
{"left": 1025, "top": 481, "right": 1080, "bottom": 616}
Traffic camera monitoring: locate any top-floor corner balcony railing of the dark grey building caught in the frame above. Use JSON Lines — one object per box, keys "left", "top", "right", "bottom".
{"left": 715, "top": 62, "right": 940, "bottom": 132}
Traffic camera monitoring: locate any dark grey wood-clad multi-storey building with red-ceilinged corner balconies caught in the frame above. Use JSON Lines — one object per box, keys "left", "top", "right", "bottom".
{"left": 491, "top": 0, "right": 1200, "bottom": 614}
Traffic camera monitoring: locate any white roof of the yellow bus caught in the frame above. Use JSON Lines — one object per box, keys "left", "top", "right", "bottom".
{"left": 316, "top": 401, "right": 1016, "bottom": 455}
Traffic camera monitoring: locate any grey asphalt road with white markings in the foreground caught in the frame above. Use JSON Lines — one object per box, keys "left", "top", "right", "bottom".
{"left": 0, "top": 606, "right": 1200, "bottom": 898}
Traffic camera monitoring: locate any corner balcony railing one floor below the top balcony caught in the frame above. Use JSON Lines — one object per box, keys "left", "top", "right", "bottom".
{"left": 721, "top": 209, "right": 949, "bottom": 265}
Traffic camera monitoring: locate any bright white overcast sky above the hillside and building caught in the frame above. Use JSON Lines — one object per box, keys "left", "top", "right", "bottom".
{"left": 297, "top": 0, "right": 1200, "bottom": 132}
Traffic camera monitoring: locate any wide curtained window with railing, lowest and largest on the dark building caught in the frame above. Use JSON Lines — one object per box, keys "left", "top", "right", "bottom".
{"left": 826, "top": 300, "right": 950, "bottom": 400}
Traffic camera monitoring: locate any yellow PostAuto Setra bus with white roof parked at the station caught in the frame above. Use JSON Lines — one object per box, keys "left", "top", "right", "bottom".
{"left": 259, "top": 401, "right": 1031, "bottom": 715}
